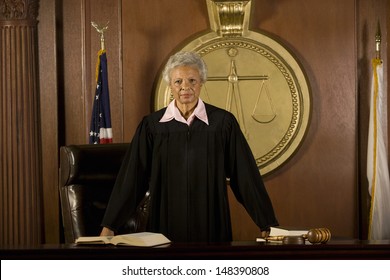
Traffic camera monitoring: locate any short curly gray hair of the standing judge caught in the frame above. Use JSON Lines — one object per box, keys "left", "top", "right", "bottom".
{"left": 163, "top": 51, "right": 207, "bottom": 84}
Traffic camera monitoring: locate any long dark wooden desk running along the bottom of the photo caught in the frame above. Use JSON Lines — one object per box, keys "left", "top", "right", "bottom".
{"left": 0, "top": 240, "right": 390, "bottom": 260}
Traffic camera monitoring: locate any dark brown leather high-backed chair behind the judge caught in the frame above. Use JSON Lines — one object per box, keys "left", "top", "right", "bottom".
{"left": 59, "top": 143, "right": 149, "bottom": 243}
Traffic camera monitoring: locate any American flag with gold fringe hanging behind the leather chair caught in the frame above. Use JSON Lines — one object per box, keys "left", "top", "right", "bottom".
{"left": 89, "top": 50, "right": 112, "bottom": 144}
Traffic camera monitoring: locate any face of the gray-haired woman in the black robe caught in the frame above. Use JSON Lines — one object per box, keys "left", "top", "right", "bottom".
{"left": 170, "top": 66, "right": 202, "bottom": 106}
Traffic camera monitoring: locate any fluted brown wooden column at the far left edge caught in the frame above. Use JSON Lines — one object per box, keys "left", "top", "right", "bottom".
{"left": 0, "top": 0, "right": 42, "bottom": 244}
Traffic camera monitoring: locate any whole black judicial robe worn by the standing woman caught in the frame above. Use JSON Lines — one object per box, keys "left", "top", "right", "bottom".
{"left": 102, "top": 101, "right": 278, "bottom": 242}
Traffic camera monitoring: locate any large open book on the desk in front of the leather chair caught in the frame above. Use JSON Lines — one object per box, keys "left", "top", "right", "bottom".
{"left": 75, "top": 232, "right": 171, "bottom": 247}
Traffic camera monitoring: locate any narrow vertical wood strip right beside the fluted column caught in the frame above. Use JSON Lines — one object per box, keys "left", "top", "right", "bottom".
{"left": 38, "top": 0, "right": 63, "bottom": 243}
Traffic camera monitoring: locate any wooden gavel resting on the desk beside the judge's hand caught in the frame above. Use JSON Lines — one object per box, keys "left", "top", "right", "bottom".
{"left": 266, "top": 228, "right": 331, "bottom": 244}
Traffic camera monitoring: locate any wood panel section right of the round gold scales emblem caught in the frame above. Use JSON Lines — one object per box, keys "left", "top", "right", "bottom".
{"left": 251, "top": 0, "right": 357, "bottom": 237}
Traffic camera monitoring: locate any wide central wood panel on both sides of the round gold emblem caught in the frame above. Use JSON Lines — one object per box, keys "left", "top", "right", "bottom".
{"left": 118, "top": 0, "right": 357, "bottom": 239}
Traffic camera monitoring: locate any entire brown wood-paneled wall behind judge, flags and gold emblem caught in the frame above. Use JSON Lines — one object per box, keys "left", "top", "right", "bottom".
{"left": 29, "top": 0, "right": 389, "bottom": 241}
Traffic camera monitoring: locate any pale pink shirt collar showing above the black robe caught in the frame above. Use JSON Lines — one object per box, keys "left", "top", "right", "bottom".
{"left": 160, "top": 98, "right": 209, "bottom": 126}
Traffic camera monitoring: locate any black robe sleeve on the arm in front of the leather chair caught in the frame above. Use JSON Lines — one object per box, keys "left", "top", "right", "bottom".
{"left": 101, "top": 118, "right": 152, "bottom": 232}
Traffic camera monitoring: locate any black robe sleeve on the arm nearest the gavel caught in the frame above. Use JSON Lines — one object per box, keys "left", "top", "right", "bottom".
{"left": 224, "top": 114, "right": 278, "bottom": 230}
